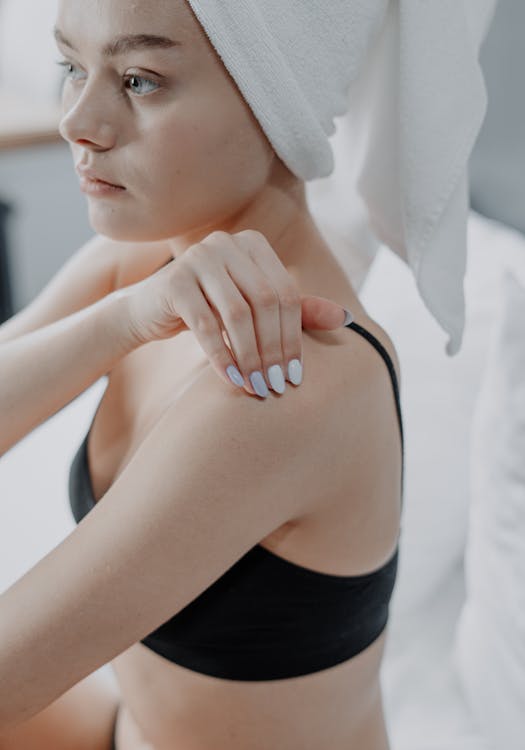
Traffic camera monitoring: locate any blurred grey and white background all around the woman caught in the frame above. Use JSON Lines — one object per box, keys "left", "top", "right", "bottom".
{"left": 0, "top": 0, "right": 525, "bottom": 750}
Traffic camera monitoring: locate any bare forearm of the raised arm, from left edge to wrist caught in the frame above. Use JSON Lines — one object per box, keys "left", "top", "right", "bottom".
{"left": 0, "top": 293, "right": 138, "bottom": 456}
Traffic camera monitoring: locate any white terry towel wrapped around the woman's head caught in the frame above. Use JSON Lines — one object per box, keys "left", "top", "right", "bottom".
{"left": 188, "top": 0, "right": 497, "bottom": 355}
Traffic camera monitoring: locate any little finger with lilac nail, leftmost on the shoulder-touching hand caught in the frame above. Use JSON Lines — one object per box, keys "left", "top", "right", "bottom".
{"left": 170, "top": 276, "right": 246, "bottom": 396}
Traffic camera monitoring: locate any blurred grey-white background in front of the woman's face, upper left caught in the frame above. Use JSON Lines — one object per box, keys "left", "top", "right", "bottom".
{"left": 0, "top": 0, "right": 93, "bottom": 319}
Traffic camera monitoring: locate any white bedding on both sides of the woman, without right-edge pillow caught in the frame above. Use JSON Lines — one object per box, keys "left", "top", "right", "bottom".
{"left": 0, "top": 213, "right": 525, "bottom": 750}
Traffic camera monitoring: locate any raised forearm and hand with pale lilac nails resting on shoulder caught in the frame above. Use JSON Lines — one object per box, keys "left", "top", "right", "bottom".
{"left": 0, "top": 230, "right": 352, "bottom": 456}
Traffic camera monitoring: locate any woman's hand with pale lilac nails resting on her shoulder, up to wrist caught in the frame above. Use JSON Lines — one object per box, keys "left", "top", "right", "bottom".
{"left": 117, "top": 230, "right": 345, "bottom": 395}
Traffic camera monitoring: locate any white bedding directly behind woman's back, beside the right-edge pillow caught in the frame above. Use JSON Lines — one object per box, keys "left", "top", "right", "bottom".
{"left": 361, "top": 212, "right": 525, "bottom": 750}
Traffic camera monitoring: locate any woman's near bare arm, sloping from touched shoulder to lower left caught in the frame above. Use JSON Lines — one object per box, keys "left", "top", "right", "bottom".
{"left": 0, "top": 350, "right": 344, "bottom": 726}
